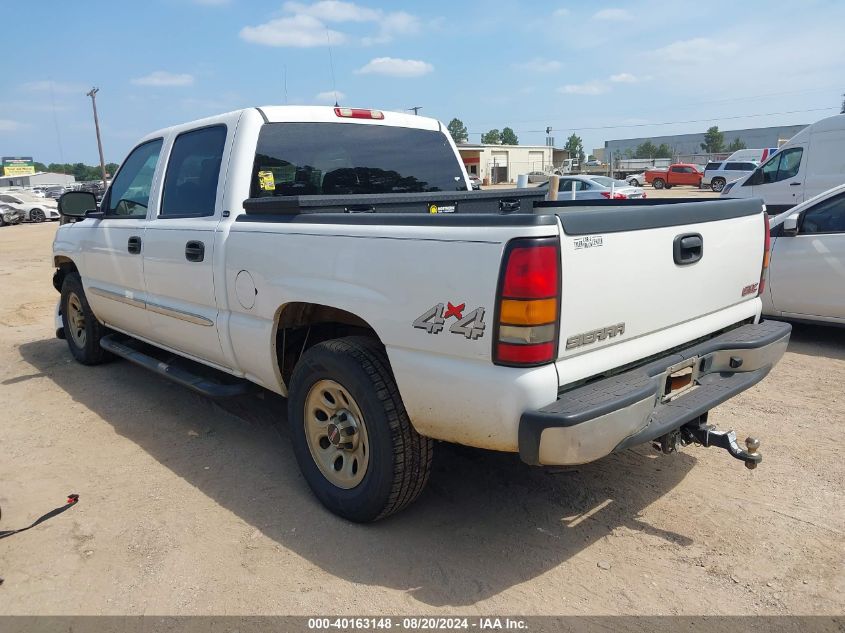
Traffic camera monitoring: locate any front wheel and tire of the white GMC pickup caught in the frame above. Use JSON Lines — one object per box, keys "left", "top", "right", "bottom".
{"left": 61, "top": 273, "right": 112, "bottom": 365}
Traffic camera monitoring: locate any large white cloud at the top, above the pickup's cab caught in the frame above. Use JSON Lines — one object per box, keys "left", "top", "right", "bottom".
{"left": 240, "top": 0, "right": 420, "bottom": 48}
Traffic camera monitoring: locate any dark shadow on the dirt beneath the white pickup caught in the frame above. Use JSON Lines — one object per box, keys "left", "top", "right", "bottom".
{"left": 20, "top": 340, "right": 695, "bottom": 606}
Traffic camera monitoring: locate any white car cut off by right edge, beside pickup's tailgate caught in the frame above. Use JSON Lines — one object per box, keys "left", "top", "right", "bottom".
{"left": 761, "top": 185, "right": 845, "bottom": 325}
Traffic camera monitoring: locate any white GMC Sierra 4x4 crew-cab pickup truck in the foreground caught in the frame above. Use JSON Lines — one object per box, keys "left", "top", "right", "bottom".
{"left": 53, "top": 106, "right": 790, "bottom": 521}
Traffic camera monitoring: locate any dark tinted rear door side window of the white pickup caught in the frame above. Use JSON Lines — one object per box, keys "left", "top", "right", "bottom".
{"left": 159, "top": 125, "right": 226, "bottom": 218}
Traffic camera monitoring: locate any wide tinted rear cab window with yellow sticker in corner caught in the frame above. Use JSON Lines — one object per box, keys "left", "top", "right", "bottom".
{"left": 250, "top": 123, "right": 467, "bottom": 198}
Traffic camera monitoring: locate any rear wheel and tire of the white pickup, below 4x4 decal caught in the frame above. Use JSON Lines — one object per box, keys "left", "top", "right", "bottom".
{"left": 288, "top": 336, "right": 434, "bottom": 523}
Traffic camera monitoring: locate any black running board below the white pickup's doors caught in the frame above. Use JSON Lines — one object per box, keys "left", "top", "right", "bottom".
{"left": 100, "top": 334, "right": 260, "bottom": 398}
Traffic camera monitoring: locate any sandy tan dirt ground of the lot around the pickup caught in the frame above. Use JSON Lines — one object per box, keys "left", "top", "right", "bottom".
{"left": 0, "top": 217, "right": 845, "bottom": 615}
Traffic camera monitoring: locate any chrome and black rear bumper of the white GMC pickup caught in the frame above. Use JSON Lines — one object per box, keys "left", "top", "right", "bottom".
{"left": 519, "top": 321, "right": 792, "bottom": 465}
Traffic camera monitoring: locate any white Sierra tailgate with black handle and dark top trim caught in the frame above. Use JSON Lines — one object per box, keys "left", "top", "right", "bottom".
{"left": 544, "top": 199, "right": 765, "bottom": 360}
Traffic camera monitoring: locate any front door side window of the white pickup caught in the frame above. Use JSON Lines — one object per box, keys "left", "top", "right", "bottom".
{"left": 105, "top": 139, "right": 162, "bottom": 218}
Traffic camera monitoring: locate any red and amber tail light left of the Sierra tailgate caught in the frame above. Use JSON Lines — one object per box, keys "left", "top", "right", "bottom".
{"left": 493, "top": 237, "right": 560, "bottom": 367}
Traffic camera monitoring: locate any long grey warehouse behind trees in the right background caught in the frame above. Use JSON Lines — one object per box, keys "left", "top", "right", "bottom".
{"left": 604, "top": 125, "right": 807, "bottom": 160}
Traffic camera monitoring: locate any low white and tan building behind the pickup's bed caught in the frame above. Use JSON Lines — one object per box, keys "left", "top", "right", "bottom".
{"left": 458, "top": 143, "right": 569, "bottom": 184}
